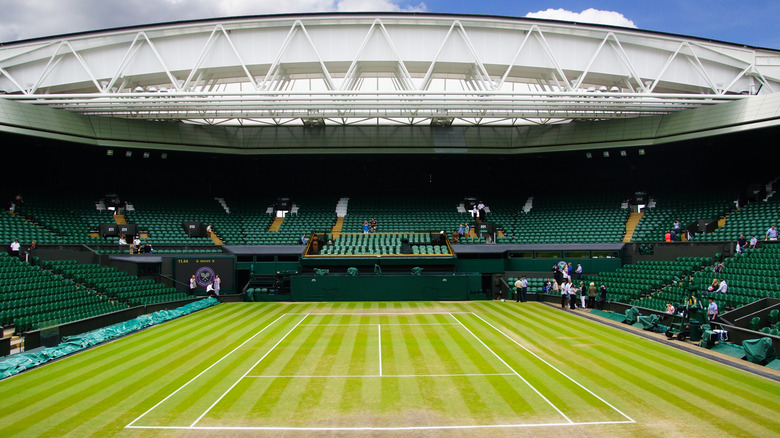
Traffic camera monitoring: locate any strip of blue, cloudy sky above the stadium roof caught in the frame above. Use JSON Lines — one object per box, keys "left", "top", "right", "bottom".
{"left": 0, "top": 0, "right": 780, "bottom": 50}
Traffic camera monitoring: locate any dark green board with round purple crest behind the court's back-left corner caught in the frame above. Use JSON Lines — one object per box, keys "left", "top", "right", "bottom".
{"left": 174, "top": 257, "right": 235, "bottom": 295}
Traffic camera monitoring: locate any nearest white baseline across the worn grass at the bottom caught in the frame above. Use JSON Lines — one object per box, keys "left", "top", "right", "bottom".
{"left": 128, "top": 421, "right": 634, "bottom": 432}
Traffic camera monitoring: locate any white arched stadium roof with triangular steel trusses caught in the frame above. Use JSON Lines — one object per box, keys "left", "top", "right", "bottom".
{"left": 0, "top": 13, "right": 780, "bottom": 126}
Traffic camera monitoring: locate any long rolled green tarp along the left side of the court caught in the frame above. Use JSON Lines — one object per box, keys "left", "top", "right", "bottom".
{"left": 0, "top": 298, "right": 219, "bottom": 378}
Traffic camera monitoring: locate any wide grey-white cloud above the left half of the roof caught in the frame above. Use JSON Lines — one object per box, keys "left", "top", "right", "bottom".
{"left": 0, "top": 0, "right": 427, "bottom": 42}
